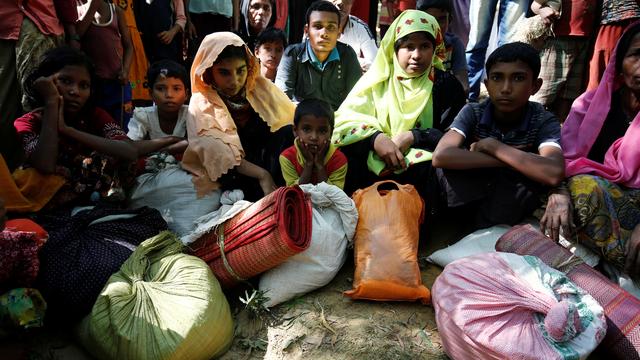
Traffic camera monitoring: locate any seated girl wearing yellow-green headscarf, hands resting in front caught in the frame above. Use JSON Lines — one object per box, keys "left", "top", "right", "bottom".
{"left": 332, "top": 10, "right": 465, "bottom": 198}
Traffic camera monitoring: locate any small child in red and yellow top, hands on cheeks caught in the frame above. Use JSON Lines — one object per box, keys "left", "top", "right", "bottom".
{"left": 280, "top": 99, "right": 347, "bottom": 189}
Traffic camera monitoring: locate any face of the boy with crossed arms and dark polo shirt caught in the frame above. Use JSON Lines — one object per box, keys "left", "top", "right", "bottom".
{"left": 484, "top": 60, "right": 542, "bottom": 116}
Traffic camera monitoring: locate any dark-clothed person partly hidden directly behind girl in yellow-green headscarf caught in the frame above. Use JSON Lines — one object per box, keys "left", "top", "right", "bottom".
{"left": 416, "top": 0, "right": 469, "bottom": 94}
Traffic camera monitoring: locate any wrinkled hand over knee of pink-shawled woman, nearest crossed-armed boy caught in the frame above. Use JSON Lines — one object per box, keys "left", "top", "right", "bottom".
{"left": 540, "top": 191, "right": 574, "bottom": 241}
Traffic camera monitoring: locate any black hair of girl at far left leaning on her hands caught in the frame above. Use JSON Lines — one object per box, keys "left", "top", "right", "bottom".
{"left": 22, "top": 46, "right": 96, "bottom": 110}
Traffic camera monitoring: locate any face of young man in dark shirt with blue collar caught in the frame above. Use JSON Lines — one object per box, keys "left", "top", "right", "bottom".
{"left": 304, "top": 11, "right": 339, "bottom": 61}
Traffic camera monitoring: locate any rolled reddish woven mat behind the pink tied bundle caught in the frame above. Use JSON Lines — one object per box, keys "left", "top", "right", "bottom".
{"left": 496, "top": 225, "right": 640, "bottom": 359}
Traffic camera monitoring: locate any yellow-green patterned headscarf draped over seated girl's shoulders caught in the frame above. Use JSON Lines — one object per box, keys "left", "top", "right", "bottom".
{"left": 332, "top": 10, "right": 445, "bottom": 175}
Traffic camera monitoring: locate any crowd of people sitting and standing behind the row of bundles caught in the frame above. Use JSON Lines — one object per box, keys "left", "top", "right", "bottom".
{"left": 0, "top": 0, "right": 640, "bottom": 346}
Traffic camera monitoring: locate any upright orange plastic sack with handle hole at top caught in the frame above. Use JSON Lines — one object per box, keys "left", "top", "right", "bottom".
{"left": 344, "top": 181, "right": 431, "bottom": 304}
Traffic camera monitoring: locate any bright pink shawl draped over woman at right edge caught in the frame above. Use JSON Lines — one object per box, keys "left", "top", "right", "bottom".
{"left": 562, "top": 20, "right": 640, "bottom": 188}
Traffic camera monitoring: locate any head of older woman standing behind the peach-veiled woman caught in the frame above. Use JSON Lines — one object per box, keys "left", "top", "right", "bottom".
{"left": 238, "top": 0, "right": 276, "bottom": 49}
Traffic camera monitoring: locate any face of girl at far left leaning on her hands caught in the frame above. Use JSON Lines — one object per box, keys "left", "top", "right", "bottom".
{"left": 55, "top": 65, "right": 91, "bottom": 114}
